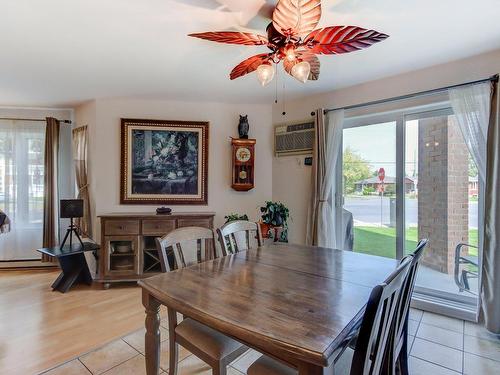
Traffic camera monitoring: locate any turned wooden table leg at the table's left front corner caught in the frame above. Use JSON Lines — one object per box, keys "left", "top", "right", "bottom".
{"left": 142, "top": 289, "right": 160, "bottom": 375}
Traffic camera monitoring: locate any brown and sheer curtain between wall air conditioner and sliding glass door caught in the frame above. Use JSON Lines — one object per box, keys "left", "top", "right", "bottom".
{"left": 306, "top": 109, "right": 344, "bottom": 247}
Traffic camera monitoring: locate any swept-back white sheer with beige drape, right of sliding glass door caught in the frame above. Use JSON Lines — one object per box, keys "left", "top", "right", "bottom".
{"left": 449, "top": 82, "right": 500, "bottom": 334}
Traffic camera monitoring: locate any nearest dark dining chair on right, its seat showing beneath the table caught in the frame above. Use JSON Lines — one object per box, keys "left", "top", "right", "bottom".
{"left": 247, "top": 257, "right": 411, "bottom": 375}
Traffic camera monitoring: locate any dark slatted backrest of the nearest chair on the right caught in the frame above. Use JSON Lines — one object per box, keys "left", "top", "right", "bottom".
{"left": 350, "top": 258, "right": 411, "bottom": 375}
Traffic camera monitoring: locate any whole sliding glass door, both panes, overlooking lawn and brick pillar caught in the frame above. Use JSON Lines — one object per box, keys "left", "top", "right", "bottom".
{"left": 337, "top": 105, "right": 482, "bottom": 318}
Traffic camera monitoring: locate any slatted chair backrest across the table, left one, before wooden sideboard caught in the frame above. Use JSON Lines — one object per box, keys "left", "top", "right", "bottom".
{"left": 156, "top": 227, "right": 215, "bottom": 272}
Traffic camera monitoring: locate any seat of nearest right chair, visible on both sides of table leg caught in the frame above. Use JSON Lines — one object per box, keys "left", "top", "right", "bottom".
{"left": 247, "top": 348, "right": 354, "bottom": 375}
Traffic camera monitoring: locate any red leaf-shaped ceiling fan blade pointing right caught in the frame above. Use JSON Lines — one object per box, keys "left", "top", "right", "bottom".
{"left": 304, "top": 26, "right": 389, "bottom": 55}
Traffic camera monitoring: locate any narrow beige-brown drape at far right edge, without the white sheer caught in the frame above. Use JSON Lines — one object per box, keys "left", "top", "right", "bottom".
{"left": 481, "top": 81, "right": 500, "bottom": 334}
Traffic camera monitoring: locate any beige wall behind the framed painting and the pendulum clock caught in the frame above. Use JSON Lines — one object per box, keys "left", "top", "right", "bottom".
{"left": 75, "top": 98, "right": 272, "bottom": 238}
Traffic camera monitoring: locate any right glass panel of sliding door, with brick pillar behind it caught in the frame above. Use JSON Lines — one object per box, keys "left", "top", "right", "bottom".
{"left": 403, "top": 109, "right": 482, "bottom": 309}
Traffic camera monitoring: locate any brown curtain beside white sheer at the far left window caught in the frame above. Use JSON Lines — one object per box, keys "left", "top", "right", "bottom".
{"left": 42, "top": 117, "right": 60, "bottom": 262}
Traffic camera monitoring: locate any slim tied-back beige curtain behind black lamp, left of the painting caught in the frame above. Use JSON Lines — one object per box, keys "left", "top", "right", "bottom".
{"left": 73, "top": 126, "right": 92, "bottom": 238}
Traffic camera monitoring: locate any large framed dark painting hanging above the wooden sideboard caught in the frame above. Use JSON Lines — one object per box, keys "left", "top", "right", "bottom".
{"left": 120, "top": 119, "right": 208, "bottom": 205}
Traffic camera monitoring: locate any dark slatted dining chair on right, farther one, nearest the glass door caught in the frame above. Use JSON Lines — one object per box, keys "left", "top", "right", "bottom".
{"left": 385, "top": 239, "right": 429, "bottom": 375}
